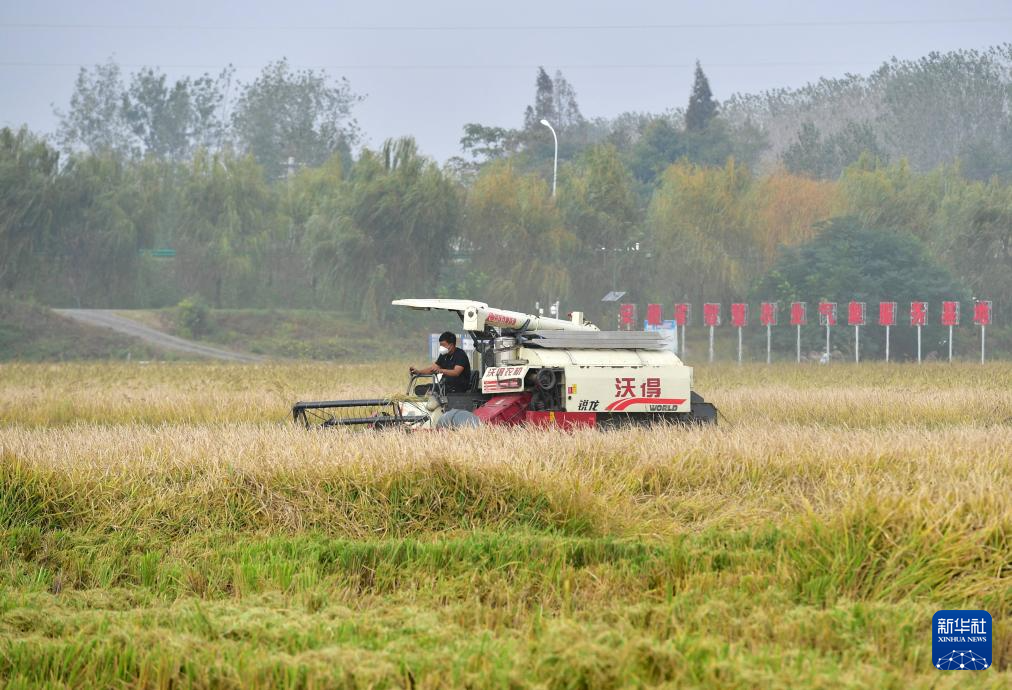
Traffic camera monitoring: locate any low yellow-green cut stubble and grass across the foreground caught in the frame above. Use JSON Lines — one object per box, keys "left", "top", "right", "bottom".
{"left": 0, "top": 510, "right": 1012, "bottom": 688}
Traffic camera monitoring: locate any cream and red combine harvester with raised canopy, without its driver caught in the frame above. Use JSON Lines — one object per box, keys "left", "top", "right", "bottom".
{"left": 291, "top": 299, "right": 716, "bottom": 429}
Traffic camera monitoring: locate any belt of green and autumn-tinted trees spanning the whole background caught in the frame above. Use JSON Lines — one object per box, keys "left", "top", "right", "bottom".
{"left": 0, "top": 49, "right": 1012, "bottom": 333}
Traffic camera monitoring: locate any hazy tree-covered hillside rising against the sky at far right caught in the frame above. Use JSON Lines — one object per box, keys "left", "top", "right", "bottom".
{"left": 722, "top": 44, "right": 1012, "bottom": 180}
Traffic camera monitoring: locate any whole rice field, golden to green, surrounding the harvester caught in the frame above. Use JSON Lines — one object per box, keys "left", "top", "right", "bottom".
{"left": 0, "top": 362, "right": 1012, "bottom": 690}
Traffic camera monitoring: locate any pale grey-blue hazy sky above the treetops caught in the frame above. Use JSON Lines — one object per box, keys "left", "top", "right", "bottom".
{"left": 0, "top": 0, "right": 1012, "bottom": 160}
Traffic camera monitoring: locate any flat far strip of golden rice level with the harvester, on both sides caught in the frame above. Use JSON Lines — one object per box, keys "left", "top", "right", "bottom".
{"left": 0, "top": 362, "right": 1012, "bottom": 428}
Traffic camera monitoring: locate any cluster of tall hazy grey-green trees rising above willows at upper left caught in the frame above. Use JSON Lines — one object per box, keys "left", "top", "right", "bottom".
{"left": 56, "top": 60, "right": 360, "bottom": 179}
